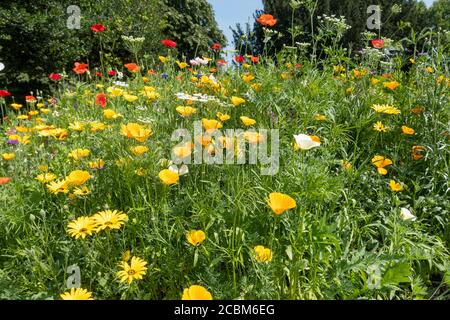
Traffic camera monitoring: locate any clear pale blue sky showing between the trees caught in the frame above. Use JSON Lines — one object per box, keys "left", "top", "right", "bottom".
{"left": 208, "top": 0, "right": 434, "bottom": 46}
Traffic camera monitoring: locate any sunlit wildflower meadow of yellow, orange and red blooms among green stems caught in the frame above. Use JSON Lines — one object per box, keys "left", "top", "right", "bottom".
{"left": 0, "top": 1, "right": 450, "bottom": 300}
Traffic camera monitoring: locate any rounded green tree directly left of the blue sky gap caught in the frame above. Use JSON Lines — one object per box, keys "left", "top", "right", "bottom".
{"left": 163, "top": 0, "right": 226, "bottom": 57}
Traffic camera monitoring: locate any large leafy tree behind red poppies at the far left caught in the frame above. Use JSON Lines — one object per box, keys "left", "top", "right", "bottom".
{"left": 0, "top": 0, "right": 162, "bottom": 98}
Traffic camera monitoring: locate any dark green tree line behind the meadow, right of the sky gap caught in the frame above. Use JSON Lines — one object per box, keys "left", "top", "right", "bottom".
{"left": 232, "top": 0, "right": 450, "bottom": 54}
